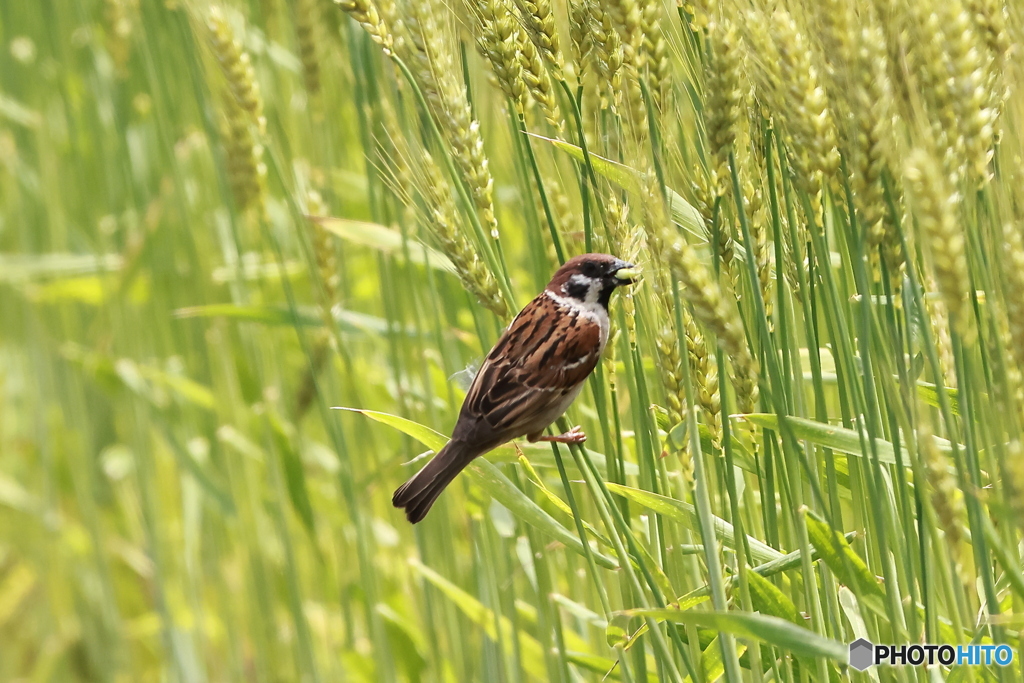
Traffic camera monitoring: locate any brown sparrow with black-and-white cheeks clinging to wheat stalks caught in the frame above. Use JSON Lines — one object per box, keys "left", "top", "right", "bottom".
{"left": 391, "top": 254, "right": 638, "bottom": 524}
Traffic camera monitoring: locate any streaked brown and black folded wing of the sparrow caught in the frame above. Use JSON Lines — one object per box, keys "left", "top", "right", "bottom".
{"left": 459, "top": 294, "right": 601, "bottom": 438}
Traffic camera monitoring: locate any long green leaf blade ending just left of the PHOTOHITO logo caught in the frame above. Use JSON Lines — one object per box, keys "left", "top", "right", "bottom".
{"left": 614, "top": 607, "right": 849, "bottom": 664}
